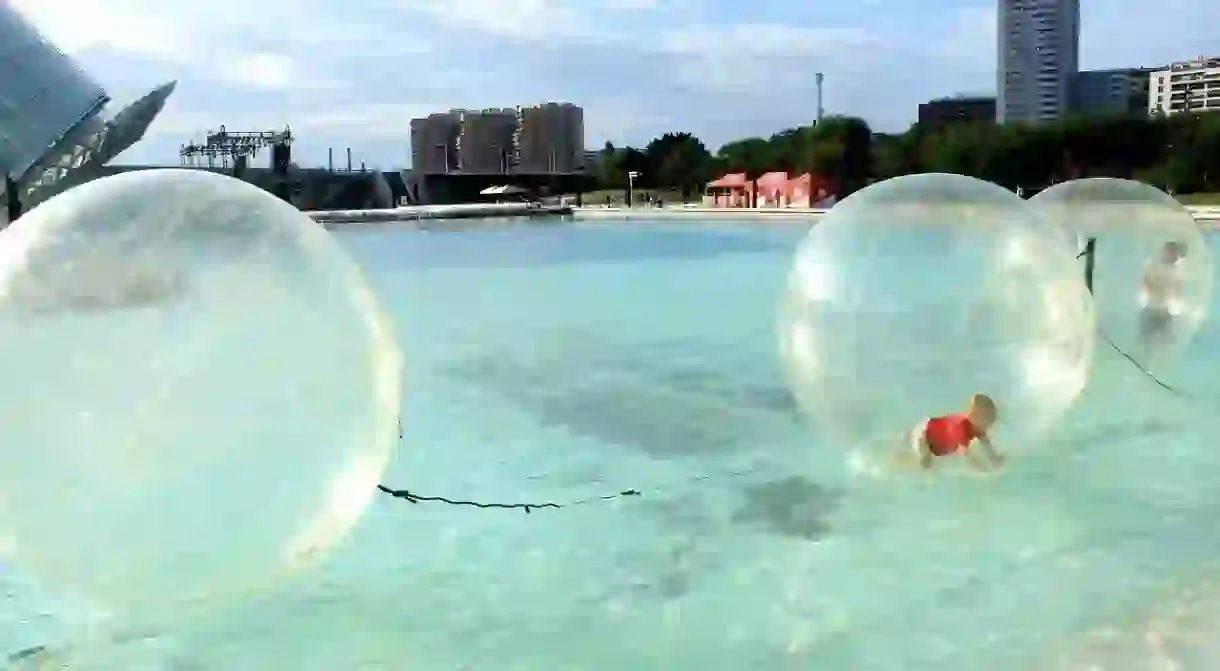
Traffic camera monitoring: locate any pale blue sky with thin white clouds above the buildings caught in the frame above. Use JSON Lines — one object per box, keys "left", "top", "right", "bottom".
{"left": 9, "top": 0, "right": 1220, "bottom": 168}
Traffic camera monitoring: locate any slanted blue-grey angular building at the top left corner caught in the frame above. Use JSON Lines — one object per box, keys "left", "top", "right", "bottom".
{"left": 0, "top": 2, "right": 174, "bottom": 218}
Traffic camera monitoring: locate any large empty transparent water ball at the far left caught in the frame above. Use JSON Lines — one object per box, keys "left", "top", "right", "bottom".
{"left": 0, "top": 170, "right": 400, "bottom": 629}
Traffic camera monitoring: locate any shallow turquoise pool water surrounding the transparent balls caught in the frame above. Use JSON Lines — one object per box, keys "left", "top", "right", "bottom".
{"left": 0, "top": 220, "right": 1220, "bottom": 671}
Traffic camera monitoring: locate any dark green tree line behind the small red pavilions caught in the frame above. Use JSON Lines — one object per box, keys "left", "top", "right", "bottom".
{"left": 592, "top": 112, "right": 1220, "bottom": 199}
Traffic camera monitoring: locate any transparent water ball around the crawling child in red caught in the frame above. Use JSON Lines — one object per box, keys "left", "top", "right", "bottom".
{"left": 780, "top": 174, "right": 1094, "bottom": 451}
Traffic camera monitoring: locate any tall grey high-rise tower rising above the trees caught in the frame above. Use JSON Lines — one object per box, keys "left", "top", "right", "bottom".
{"left": 996, "top": 0, "right": 1080, "bottom": 123}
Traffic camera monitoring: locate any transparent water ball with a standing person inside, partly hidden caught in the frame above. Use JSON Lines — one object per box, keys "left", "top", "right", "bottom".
{"left": 1030, "top": 178, "right": 1213, "bottom": 371}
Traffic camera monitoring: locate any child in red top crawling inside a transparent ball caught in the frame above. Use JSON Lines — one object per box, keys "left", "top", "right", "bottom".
{"left": 910, "top": 394, "right": 1004, "bottom": 471}
